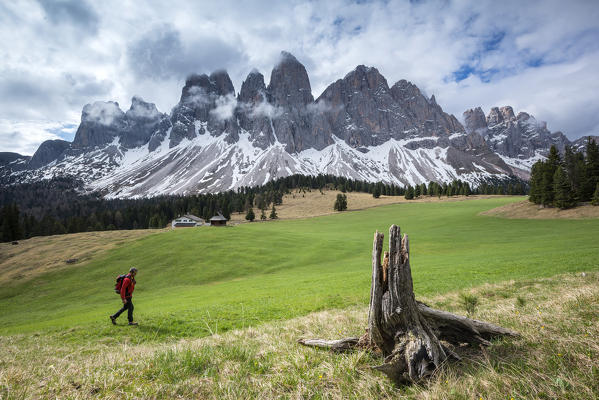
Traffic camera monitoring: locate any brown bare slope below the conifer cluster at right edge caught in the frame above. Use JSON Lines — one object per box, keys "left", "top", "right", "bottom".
{"left": 480, "top": 200, "right": 599, "bottom": 219}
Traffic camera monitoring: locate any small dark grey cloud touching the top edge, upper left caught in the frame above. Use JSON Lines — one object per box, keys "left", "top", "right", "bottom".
{"left": 38, "top": 0, "right": 100, "bottom": 33}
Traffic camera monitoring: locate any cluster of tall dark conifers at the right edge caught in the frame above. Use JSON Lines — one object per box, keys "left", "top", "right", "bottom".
{"left": 529, "top": 138, "right": 599, "bottom": 209}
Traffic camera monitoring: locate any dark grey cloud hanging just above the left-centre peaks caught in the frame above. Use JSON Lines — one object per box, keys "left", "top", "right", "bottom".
{"left": 127, "top": 25, "right": 244, "bottom": 79}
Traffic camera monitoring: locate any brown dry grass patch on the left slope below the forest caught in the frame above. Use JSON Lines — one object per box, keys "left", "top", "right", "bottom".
{"left": 0, "top": 229, "right": 160, "bottom": 285}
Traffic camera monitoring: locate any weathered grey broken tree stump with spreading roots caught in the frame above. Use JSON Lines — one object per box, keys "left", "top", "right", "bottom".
{"left": 299, "top": 225, "right": 518, "bottom": 384}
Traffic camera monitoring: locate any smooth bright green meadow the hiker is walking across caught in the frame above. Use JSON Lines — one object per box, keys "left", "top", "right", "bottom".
{"left": 0, "top": 197, "right": 599, "bottom": 343}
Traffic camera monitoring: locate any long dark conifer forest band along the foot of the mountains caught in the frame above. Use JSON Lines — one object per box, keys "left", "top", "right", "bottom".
{"left": 0, "top": 175, "right": 524, "bottom": 241}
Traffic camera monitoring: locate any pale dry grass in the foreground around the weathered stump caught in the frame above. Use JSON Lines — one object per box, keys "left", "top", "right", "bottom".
{"left": 0, "top": 272, "right": 599, "bottom": 399}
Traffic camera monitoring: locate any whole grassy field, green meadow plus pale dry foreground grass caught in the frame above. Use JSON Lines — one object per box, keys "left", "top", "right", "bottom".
{"left": 0, "top": 197, "right": 599, "bottom": 399}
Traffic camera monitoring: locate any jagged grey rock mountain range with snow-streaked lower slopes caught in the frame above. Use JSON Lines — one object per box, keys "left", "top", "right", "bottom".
{"left": 0, "top": 52, "right": 584, "bottom": 197}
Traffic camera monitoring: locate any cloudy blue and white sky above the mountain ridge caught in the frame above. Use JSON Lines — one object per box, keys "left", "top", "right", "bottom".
{"left": 0, "top": 0, "right": 599, "bottom": 155}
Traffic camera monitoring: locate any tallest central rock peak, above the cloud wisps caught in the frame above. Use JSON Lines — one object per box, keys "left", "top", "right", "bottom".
{"left": 268, "top": 51, "right": 314, "bottom": 107}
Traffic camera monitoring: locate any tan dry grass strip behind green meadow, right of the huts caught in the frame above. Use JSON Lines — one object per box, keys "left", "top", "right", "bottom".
{"left": 231, "top": 189, "right": 516, "bottom": 223}
